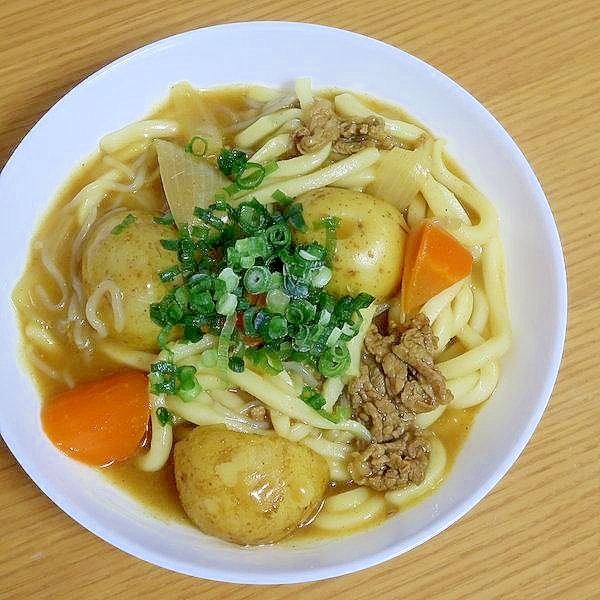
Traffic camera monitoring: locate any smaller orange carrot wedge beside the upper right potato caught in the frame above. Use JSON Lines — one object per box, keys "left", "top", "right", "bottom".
{"left": 400, "top": 219, "right": 473, "bottom": 314}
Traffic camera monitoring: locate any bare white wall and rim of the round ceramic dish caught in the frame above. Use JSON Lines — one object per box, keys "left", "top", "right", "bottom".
{"left": 0, "top": 22, "right": 566, "bottom": 584}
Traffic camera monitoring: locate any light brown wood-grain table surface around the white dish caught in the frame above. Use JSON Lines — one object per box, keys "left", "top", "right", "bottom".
{"left": 0, "top": 0, "right": 600, "bottom": 600}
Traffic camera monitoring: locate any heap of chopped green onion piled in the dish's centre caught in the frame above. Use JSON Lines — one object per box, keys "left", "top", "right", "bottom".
{"left": 150, "top": 191, "right": 373, "bottom": 380}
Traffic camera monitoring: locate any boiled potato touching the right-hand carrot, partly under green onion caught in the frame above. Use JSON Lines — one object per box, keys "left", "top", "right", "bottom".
{"left": 296, "top": 187, "right": 406, "bottom": 300}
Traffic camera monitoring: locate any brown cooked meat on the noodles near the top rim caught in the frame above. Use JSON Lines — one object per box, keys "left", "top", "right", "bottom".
{"left": 292, "top": 99, "right": 396, "bottom": 154}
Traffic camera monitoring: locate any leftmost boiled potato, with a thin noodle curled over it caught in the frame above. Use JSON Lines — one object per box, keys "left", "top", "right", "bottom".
{"left": 82, "top": 209, "right": 177, "bottom": 351}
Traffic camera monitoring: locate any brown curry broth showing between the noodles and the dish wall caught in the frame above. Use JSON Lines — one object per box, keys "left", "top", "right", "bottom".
{"left": 13, "top": 86, "right": 488, "bottom": 539}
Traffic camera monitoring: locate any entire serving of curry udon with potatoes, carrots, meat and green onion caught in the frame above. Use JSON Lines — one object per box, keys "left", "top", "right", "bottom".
{"left": 13, "top": 79, "right": 510, "bottom": 545}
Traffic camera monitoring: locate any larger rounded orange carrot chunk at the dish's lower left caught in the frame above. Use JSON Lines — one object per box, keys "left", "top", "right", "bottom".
{"left": 42, "top": 371, "right": 150, "bottom": 466}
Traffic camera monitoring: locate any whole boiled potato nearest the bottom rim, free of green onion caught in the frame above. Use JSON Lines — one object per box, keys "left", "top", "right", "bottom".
{"left": 174, "top": 425, "right": 329, "bottom": 545}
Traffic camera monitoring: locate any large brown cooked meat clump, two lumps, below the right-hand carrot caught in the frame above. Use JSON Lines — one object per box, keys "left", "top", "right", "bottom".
{"left": 345, "top": 314, "right": 452, "bottom": 490}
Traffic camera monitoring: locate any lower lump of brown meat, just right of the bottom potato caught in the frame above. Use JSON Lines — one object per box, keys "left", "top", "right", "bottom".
{"left": 348, "top": 429, "right": 430, "bottom": 491}
